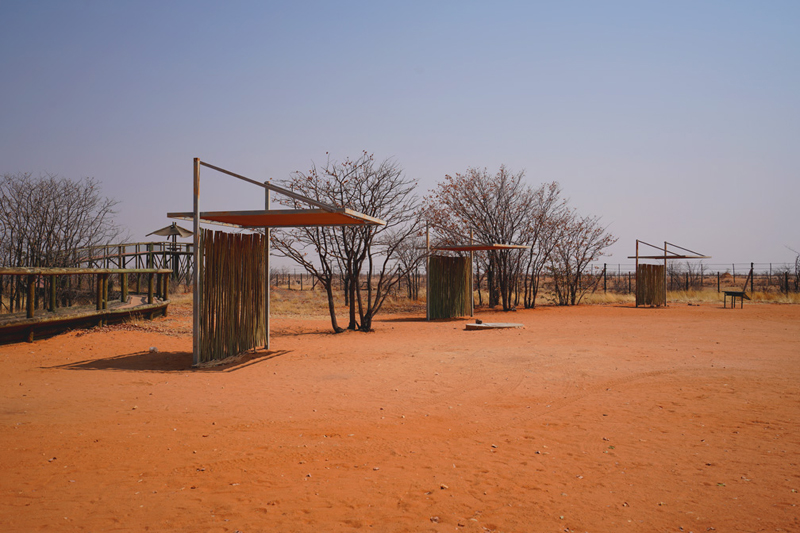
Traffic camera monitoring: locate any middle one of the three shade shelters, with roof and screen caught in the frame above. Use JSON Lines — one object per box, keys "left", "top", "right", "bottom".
{"left": 426, "top": 227, "right": 530, "bottom": 320}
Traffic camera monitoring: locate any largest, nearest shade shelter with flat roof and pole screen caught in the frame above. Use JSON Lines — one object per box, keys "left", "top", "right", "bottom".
{"left": 167, "top": 158, "right": 385, "bottom": 366}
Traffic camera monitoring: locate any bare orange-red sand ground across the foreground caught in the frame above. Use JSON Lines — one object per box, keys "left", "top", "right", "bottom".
{"left": 0, "top": 303, "right": 800, "bottom": 533}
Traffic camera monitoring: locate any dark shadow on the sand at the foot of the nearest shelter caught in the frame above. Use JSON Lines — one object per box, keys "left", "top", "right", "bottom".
{"left": 44, "top": 350, "right": 289, "bottom": 373}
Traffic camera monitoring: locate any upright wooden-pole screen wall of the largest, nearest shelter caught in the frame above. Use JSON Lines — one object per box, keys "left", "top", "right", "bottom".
{"left": 199, "top": 230, "right": 267, "bottom": 363}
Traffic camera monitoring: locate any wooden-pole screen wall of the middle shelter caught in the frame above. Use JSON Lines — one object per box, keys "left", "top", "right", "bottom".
{"left": 428, "top": 255, "right": 472, "bottom": 319}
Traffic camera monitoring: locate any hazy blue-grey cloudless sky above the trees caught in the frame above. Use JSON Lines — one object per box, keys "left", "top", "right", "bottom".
{"left": 0, "top": 0, "right": 800, "bottom": 264}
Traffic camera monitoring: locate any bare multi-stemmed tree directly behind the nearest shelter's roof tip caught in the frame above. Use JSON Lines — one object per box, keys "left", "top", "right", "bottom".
{"left": 273, "top": 152, "right": 423, "bottom": 331}
